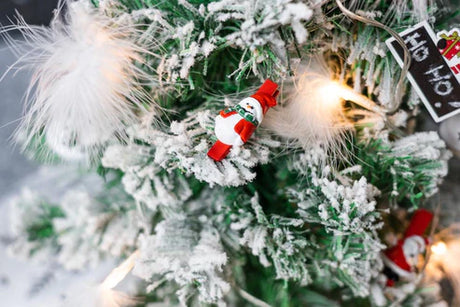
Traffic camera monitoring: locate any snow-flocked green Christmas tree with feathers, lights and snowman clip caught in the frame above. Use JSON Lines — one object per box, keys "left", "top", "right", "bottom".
{"left": 6, "top": 0, "right": 455, "bottom": 306}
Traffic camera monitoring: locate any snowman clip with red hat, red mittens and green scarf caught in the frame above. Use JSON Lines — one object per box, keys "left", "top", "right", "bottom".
{"left": 208, "top": 80, "right": 279, "bottom": 161}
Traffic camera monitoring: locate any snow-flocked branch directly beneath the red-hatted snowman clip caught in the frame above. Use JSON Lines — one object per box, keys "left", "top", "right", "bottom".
{"left": 103, "top": 110, "right": 279, "bottom": 188}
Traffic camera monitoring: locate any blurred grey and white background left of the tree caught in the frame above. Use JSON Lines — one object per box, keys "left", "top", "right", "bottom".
{"left": 0, "top": 0, "right": 118, "bottom": 307}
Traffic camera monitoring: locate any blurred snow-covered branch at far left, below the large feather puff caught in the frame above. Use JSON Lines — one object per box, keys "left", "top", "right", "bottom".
{"left": 9, "top": 185, "right": 142, "bottom": 270}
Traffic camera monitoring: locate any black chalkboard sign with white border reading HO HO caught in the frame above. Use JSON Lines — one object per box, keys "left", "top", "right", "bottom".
{"left": 386, "top": 22, "right": 460, "bottom": 122}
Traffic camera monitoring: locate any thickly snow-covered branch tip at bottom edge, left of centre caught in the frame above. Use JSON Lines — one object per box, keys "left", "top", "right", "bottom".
{"left": 134, "top": 216, "right": 230, "bottom": 306}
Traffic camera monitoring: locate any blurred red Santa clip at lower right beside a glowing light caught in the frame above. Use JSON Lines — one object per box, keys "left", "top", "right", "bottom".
{"left": 383, "top": 209, "right": 433, "bottom": 287}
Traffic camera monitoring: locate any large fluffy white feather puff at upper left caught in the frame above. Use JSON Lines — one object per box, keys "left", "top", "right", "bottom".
{"left": 3, "top": 1, "right": 153, "bottom": 160}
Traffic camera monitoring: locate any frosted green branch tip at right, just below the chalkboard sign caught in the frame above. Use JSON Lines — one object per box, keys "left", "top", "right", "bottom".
{"left": 355, "top": 132, "right": 452, "bottom": 205}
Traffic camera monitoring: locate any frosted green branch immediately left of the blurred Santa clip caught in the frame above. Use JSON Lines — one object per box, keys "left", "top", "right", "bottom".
{"left": 289, "top": 150, "right": 384, "bottom": 296}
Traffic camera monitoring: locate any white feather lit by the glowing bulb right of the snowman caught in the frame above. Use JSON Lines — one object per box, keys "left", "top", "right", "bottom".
{"left": 262, "top": 61, "right": 352, "bottom": 161}
